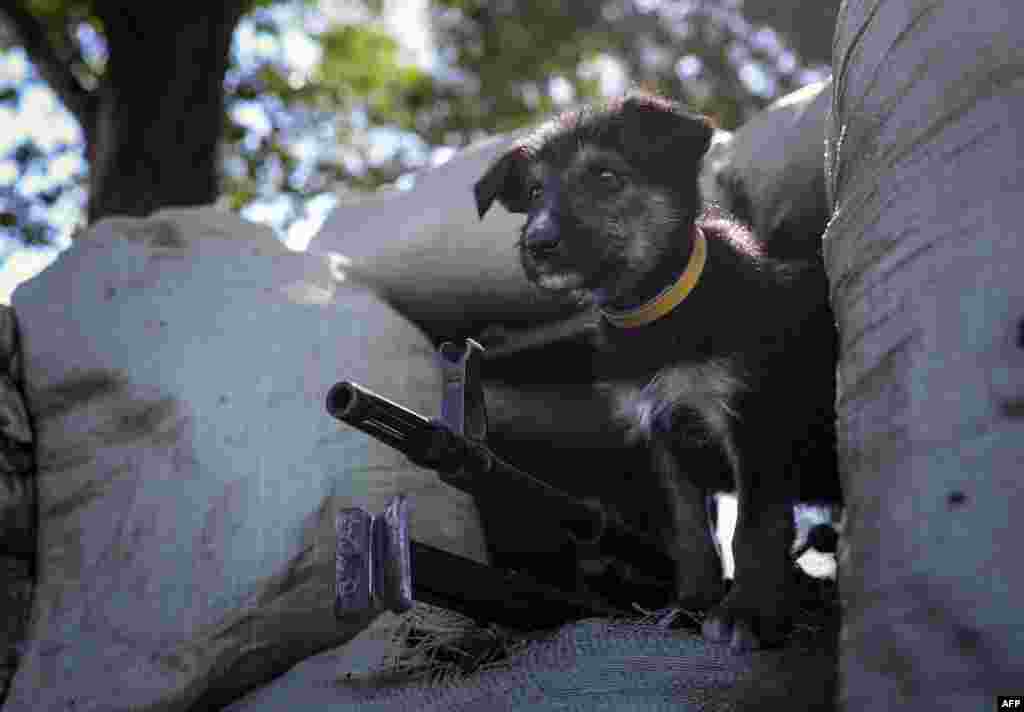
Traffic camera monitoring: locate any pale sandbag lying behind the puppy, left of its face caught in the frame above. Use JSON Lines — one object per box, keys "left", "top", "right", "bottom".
{"left": 308, "top": 136, "right": 575, "bottom": 340}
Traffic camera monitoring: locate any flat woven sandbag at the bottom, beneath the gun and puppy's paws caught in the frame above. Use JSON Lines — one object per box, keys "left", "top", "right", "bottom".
{"left": 225, "top": 619, "right": 836, "bottom": 712}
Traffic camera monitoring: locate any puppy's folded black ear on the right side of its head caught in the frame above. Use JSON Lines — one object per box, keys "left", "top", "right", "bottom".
{"left": 620, "top": 92, "right": 715, "bottom": 161}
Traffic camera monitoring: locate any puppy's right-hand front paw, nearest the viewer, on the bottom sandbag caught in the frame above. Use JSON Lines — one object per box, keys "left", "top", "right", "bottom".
{"left": 701, "top": 585, "right": 793, "bottom": 652}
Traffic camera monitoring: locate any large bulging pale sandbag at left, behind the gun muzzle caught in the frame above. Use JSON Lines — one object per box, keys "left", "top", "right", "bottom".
{"left": 4, "top": 209, "right": 485, "bottom": 712}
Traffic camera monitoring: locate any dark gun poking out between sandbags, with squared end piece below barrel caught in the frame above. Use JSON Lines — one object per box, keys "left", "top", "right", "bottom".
{"left": 326, "top": 339, "right": 672, "bottom": 629}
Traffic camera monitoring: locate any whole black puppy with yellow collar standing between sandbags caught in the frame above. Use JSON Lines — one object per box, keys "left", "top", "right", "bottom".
{"left": 474, "top": 93, "right": 839, "bottom": 650}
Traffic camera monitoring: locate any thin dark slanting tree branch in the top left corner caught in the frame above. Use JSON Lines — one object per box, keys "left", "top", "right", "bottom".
{"left": 0, "top": 0, "right": 96, "bottom": 129}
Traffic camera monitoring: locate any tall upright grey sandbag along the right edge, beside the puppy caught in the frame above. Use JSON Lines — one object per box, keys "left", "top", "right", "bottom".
{"left": 824, "top": 0, "right": 1024, "bottom": 711}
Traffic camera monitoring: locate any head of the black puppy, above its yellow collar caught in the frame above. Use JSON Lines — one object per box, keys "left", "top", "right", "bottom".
{"left": 474, "top": 93, "right": 713, "bottom": 303}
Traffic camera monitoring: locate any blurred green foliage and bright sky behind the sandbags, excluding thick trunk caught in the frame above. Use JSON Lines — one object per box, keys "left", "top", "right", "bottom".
{"left": 0, "top": 0, "right": 839, "bottom": 254}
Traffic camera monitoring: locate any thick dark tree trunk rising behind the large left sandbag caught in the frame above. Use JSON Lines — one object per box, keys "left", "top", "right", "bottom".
{"left": 86, "top": 0, "right": 246, "bottom": 222}
